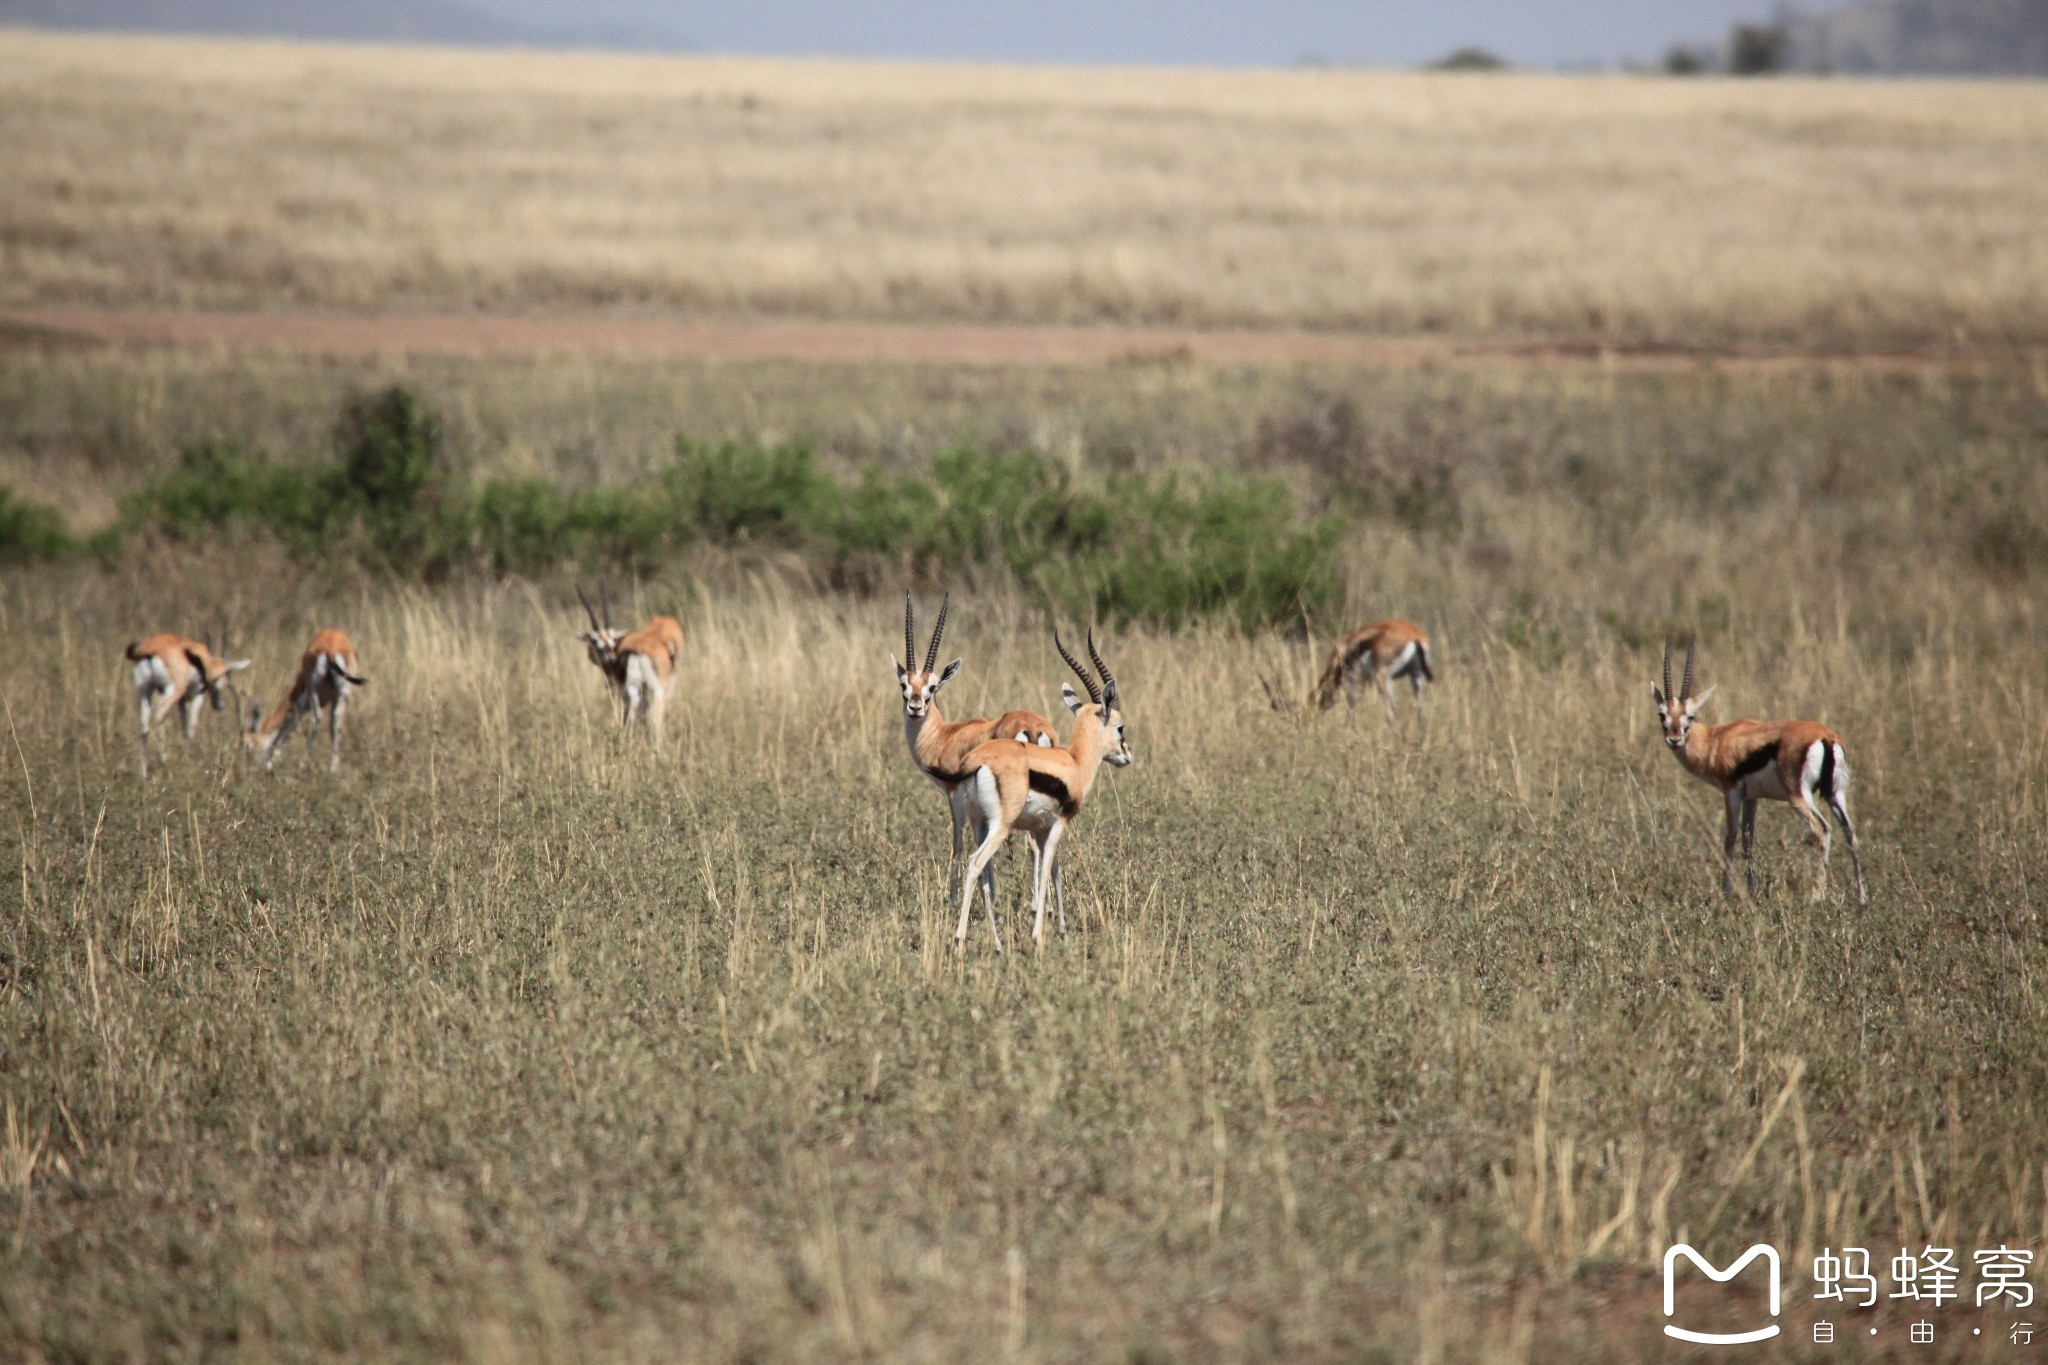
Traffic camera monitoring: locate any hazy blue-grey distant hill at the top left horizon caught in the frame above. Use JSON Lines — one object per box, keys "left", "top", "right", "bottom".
{"left": 0, "top": 0, "right": 528, "bottom": 45}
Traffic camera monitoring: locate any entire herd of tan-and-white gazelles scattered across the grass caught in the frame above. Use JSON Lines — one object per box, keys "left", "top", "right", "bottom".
{"left": 112, "top": 583, "right": 1868, "bottom": 929}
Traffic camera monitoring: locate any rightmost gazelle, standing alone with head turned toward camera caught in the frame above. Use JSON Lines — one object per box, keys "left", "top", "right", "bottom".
{"left": 1651, "top": 636, "right": 1870, "bottom": 905}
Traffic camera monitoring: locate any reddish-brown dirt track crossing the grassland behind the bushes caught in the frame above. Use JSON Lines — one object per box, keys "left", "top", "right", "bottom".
{"left": 0, "top": 309, "right": 2048, "bottom": 375}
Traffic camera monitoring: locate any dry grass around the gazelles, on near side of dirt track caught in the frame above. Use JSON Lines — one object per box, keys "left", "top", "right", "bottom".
{"left": 0, "top": 356, "right": 2048, "bottom": 1361}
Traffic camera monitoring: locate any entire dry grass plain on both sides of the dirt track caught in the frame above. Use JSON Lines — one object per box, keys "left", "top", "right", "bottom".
{"left": 0, "top": 33, "right": 2048, "bottom": 1365}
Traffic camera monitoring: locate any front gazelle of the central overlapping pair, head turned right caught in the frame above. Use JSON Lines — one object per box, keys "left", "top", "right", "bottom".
{"left": 952, "top": 630, "right": 1133, "bottom": 952}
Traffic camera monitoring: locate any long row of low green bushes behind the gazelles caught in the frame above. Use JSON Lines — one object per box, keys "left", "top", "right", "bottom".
{"left": 108, "top": 378, "right": 1337, "bottom": 626}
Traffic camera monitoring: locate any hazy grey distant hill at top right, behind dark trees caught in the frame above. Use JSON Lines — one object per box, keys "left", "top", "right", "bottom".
{"left": 1785, "top": 0, "right": 2048, "bottom": 76}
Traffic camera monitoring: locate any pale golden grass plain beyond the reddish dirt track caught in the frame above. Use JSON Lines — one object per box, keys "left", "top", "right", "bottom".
{"left": 0, "top": 33, "right": 2048, "bottom": 346}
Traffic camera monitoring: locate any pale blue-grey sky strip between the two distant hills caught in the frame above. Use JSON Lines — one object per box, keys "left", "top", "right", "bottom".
{"left": 467, "top": 0, "right": 1785, "bottom": 65}
